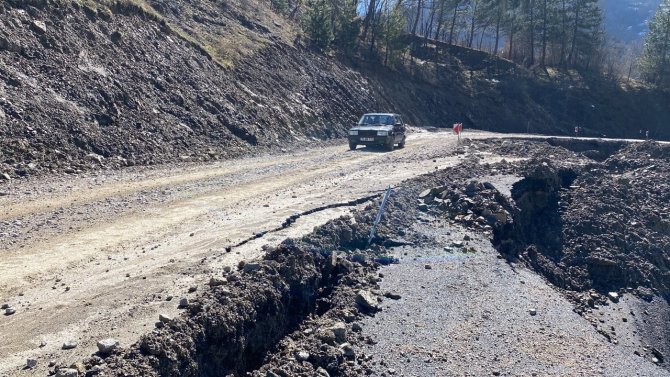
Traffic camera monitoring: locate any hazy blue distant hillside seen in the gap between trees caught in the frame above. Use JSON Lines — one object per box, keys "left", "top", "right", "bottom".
{"left": 600, "top": 0, "right": 661, "bottom": 43}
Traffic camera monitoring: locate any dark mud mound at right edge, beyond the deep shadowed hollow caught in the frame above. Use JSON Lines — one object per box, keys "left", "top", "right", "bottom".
{"left": 558, "top": 143, "right": 670, "bottom": 300}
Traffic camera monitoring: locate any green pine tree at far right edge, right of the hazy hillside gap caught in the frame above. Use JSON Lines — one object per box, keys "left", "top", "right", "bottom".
{"left": 640, "top": 0, "right": 670, "bottom": 88}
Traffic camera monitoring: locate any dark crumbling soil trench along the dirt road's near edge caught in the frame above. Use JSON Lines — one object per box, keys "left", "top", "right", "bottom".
{"left": 87, "top": 210, "right": 400, "bottom": 376}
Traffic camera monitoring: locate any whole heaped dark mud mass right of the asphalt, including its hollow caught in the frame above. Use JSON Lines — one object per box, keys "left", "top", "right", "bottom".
{"left": 421, "top": 141, "right": 670, "bottom": 305}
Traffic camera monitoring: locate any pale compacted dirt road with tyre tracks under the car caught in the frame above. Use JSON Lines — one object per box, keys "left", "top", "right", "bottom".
{"left": 0, "top": 129, "right": 504, "bottom": 376}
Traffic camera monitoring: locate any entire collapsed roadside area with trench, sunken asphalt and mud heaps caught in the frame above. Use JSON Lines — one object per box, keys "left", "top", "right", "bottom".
{"left": 43, "top": 137, "right": 670, "bottom": 376}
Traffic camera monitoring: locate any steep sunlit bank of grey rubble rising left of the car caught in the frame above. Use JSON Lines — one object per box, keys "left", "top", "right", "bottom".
{"left": 0, "top": 0, "right": 384, "bottom": 176}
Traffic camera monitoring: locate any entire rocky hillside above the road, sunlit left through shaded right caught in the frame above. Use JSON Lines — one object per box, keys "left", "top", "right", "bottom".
{"left": 0, "top": 0, "right": 670, "bottom": 180}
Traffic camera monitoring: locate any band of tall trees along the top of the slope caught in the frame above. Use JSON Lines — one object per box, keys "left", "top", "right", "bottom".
{"left": 282, "top": 0, "right": 670, "bottom": 88}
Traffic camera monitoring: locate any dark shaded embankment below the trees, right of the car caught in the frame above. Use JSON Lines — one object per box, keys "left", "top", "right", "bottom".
{"left": 415, "top": 39, "right": 670, "bottom": 140}
